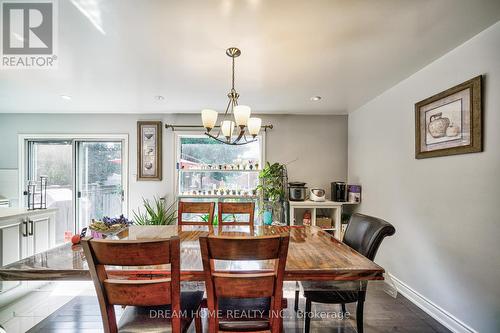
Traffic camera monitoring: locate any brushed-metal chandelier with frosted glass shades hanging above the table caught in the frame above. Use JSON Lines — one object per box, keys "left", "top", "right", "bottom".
{"left": 201, "top": 47, "right": 266, "bottom": 145}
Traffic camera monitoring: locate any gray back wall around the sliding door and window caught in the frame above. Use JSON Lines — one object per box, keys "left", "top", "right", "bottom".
{"left": 0, "top": 114, "right": 347, "bottom": 209}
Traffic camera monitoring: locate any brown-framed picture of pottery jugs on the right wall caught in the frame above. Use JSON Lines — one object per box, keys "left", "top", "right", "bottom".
{"left": 415, "top": 76, "right": 483, "bottom": 159}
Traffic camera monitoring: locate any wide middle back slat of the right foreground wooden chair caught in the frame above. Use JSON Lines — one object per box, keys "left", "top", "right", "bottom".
{"left": 213, "top": 275, "right": 276, "bottom": 298}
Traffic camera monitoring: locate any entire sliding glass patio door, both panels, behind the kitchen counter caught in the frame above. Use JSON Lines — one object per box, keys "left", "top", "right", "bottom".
{"left": 25, "top": 138, "right": 126, "bottom": 240}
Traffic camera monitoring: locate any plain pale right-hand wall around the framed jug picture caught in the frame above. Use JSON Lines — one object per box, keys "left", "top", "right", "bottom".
{"left": 348, "top": 23, "right": 500, "bottom": 333}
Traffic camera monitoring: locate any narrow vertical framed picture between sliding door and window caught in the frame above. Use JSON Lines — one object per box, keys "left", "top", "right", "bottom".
{"left": 137, "top": 121, "right": 162, "bottom": 180}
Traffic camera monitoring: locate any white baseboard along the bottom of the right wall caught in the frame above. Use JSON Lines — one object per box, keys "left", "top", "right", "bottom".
{"left": 387, "top": 273, "right": 478, "bottom": 333}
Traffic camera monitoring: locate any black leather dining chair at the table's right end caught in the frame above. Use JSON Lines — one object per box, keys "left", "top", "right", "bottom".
{"left": 294, "top": 214, "right": 396, "bottom": 333}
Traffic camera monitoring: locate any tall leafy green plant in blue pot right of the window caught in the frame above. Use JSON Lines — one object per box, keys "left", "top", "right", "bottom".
{"left": 257, "top": 162, "right": 286, "bottom": 225}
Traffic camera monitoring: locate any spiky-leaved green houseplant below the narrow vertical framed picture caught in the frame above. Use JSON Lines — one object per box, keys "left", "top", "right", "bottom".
{"left": 133, "top": 197, "right": 177, "bottom": 225}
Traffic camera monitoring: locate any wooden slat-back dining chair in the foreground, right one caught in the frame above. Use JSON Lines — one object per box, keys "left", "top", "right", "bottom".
{"left": 199, "top": 231, "right": 289, "bottom": 333}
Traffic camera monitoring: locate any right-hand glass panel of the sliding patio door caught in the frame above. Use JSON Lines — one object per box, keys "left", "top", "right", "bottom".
{"left": 77, "top": 141, "right": 124, "bottom": 229}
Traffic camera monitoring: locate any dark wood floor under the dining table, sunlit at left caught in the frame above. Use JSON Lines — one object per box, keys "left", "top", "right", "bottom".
{"left": 25, "top": 286, "right": 449, "bottom": 333}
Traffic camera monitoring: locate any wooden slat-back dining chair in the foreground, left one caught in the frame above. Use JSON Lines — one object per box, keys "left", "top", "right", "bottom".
{"left": 82, "top": 237, "right": 203, "bottom": 333}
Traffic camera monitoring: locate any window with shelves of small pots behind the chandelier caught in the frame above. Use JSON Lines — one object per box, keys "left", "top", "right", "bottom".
{"left": 176, "top": 134, "right": 263, "bottom": 198}
